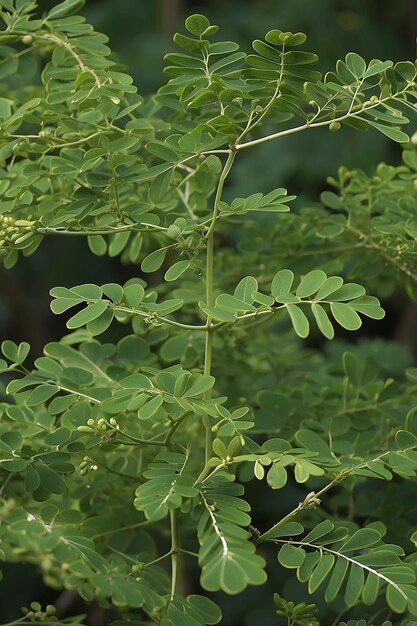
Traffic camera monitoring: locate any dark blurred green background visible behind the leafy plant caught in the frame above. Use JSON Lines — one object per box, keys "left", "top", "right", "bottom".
{"left": 0, "top": 0, "right": 417, "bottom": 626}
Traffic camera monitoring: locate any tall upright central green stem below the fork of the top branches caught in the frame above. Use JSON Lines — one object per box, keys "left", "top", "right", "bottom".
{"left": 203, "top": 149, "right": 236, "bottom": 463}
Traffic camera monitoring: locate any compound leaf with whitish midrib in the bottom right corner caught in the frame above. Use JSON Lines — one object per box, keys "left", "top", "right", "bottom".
{"left": 278, "top": 520, "right": 417, "bottom": 613}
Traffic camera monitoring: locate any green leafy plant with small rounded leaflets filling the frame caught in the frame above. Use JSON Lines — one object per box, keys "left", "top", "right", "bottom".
{"left": 0, "top": 0, "right": 417, "bottom": 626}
